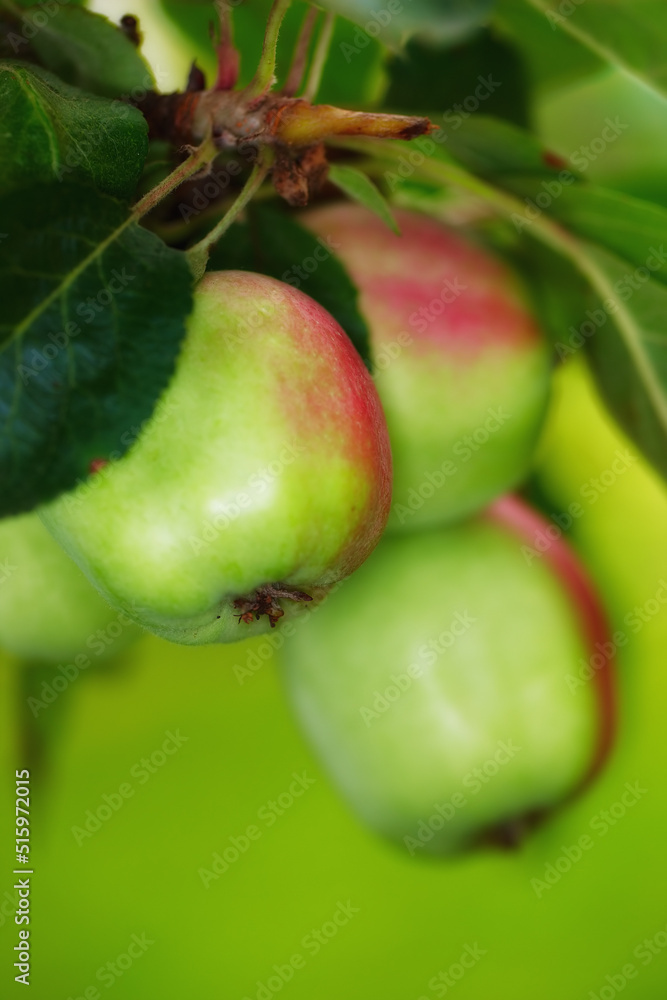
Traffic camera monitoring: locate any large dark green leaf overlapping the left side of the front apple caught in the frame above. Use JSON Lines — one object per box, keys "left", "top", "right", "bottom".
{"left": 0, "top": 184, "right": 192, "bottom": 516}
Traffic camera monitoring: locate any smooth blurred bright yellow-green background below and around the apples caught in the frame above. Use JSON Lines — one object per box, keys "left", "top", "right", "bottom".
{"left": 0, "top": 0, "right": 667, "bottom": 1000}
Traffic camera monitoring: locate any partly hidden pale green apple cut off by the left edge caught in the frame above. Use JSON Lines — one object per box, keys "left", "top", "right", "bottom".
{"left": 0, "top": 514, "right": 141, "bottom": 663}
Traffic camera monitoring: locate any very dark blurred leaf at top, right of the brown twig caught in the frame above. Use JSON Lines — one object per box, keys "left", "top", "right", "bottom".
{"left": 384, "top": 28, "right": 529, "bottom": 125}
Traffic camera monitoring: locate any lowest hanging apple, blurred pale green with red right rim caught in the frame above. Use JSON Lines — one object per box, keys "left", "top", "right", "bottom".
{"left": 283, "top": 497, "right": 614, "bottom": 855}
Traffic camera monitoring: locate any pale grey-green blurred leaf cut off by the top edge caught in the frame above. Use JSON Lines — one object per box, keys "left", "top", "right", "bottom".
{"left": 318, "top": 0, "right": 493, "bottom": 50}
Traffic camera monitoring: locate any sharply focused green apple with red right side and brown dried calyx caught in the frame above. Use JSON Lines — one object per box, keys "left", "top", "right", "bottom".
{"left": 42, "top": 271, "right": 391, "bottom": 644}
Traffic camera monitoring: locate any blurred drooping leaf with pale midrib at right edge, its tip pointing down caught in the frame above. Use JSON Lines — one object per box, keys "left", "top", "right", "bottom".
{"left": 580, "top": 244, "right": 667, "bottom": 478}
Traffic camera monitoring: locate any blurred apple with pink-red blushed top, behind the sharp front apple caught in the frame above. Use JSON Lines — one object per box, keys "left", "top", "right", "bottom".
{"left": 301, "top": 204, "right": 550, "bottom": 530}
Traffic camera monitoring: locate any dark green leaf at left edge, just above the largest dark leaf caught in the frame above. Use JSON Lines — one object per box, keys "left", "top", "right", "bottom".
{"left": 0, "top": 62, "right": 148, "bottom": 198}
